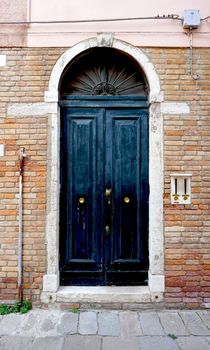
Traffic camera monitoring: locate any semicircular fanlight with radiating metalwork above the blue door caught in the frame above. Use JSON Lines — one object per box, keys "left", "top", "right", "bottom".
{"left": 60, "top": 48, "right": 148, "bottom": 98}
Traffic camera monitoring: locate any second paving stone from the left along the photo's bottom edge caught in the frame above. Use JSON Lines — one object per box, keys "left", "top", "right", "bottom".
{"left": 30, "top": 337, "right": 64, "bottom": 350}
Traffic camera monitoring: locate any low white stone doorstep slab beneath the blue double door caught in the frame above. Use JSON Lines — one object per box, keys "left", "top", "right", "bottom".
{"left": 41, "top": 286, "right": 163, "bottom": 304}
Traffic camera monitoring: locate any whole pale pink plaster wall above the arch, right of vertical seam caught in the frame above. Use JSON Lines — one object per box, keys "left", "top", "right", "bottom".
{"left": 28, "top": 0, "right": 210, "bottom": 47}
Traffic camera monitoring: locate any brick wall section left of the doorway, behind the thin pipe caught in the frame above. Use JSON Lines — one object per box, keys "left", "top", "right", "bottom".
{"left": 0, "top": 49, "right": 65, "bottom": 301}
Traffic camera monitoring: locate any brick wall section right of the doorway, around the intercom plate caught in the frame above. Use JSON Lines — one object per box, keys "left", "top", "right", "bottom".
{"left": 146, "top": 49, "right": 210, "bottom": 307}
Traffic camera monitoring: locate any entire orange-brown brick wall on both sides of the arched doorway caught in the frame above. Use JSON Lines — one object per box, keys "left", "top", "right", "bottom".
{"left": 0, "top": 48, "right": 210, "bottom": 307}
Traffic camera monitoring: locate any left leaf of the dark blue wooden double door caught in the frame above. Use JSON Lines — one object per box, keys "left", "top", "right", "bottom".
{"left": 61, "top": 108, "right": 104, "bottom": 284}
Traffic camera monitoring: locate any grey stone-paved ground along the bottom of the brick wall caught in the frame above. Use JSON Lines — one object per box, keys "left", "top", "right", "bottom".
{"left": 0, "top": 310, "right": 210, "bottom": 350}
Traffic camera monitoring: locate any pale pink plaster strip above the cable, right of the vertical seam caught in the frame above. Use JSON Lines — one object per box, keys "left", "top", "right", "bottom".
{"left": 31, "top": 0, "right": 210, "bottom": 20}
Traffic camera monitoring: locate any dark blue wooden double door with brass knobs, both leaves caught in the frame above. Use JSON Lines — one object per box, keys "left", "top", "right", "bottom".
{"left": 60, "top": 102, "right": 148, "bottom": 285}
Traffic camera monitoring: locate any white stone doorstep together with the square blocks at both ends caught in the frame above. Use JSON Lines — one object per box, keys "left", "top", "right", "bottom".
{"left": 41, "top": 272, "right": 165, "bottom": 304}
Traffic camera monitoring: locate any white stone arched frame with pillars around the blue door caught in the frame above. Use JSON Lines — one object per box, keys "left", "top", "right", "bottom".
{"left": 43, "top": 33, "right": 165, "bottom": 299}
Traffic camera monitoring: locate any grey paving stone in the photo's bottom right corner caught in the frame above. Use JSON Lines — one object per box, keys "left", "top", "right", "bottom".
{"left": 176, "top": 336, "right": 210, "bottom": 350}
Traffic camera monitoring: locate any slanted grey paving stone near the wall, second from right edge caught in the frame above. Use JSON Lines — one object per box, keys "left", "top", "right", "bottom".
{"left": 179, "top": 311, "right": 210, "bottom": 335}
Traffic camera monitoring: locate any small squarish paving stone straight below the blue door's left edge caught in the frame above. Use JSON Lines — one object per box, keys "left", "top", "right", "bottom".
{"left": 57, "top": 312, "right": 78, "bottom": 334}
